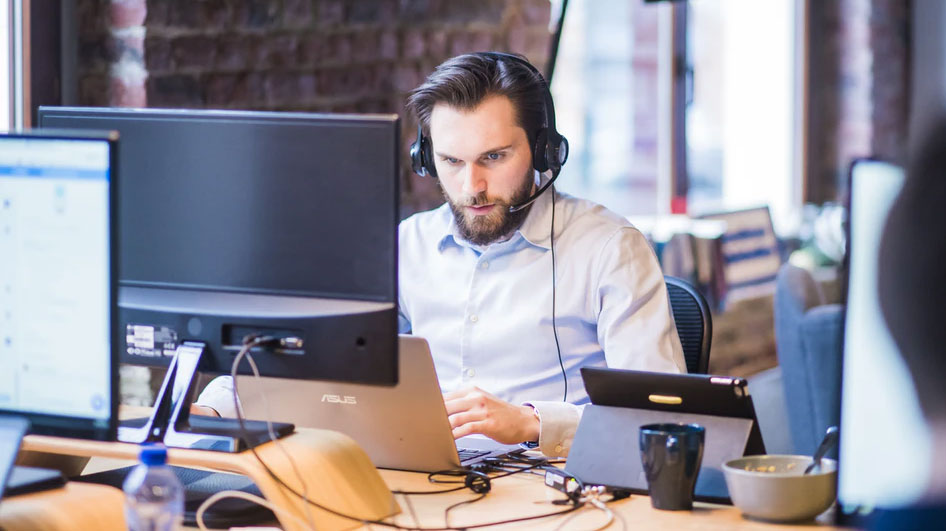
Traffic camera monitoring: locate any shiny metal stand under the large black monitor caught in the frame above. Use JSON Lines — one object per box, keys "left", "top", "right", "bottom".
{"left": 118, "top": 341, "right": 284, "bottom": 453}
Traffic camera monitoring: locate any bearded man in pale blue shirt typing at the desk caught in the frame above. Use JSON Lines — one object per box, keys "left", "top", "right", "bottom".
{"left": 399, "top": 53, "right": 686, "bottom": 456}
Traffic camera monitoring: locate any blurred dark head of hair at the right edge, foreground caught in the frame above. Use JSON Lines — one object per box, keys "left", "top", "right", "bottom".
{"left": 878, "top": 118, "right": 946, "bottom": 420}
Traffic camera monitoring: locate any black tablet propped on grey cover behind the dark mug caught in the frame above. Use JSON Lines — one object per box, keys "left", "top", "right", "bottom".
{"left": 565, "top": 367, "right": 765, "bottom": 503}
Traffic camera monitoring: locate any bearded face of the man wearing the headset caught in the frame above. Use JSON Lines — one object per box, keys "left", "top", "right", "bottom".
{"left": 430, "top": 96, "right": 534, "bottom": 245}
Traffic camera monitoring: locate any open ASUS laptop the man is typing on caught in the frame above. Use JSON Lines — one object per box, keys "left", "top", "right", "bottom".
{"left": 237, "top": 335, "right": 523, "bottom": 472}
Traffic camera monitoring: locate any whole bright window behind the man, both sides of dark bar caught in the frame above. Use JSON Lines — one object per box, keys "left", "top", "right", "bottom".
{"left": 551, "top": 0, "right": 804, "bottom": 231}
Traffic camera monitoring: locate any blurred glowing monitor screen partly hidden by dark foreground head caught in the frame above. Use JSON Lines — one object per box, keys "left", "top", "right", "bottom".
{"left": 838, "top": 160, "right": 930, "bottom": 519}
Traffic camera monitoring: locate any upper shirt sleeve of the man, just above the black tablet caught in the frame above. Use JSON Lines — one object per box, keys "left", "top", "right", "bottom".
{"left": 595, "top": 227, "right": 686, "bottom": 373}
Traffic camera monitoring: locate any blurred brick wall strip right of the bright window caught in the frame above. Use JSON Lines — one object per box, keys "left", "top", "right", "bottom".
{"left": 806, "top": 0, "right": 911, "bottom": 202}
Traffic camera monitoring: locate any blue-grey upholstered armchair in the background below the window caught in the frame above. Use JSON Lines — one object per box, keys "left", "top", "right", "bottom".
{"left": 775, "top": 264, "right": 843, "bottom": 455}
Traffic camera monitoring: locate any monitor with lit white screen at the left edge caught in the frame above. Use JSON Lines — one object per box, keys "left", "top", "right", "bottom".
{"left": 0, "top": 131, "right": 118, "bottom": 440}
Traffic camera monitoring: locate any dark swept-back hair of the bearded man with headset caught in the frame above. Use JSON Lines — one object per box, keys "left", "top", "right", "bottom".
{"left": 407, "top": 53, "right": 547, "bottom": 146}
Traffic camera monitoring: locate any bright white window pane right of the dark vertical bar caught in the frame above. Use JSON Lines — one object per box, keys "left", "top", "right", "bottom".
{"left": 685, "top": 0, "right": 802, "bottom": 230}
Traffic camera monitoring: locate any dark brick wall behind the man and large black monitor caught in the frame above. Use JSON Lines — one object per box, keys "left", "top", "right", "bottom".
{"left": 78, "top": 0, "right": 550, "bottom": 215}
